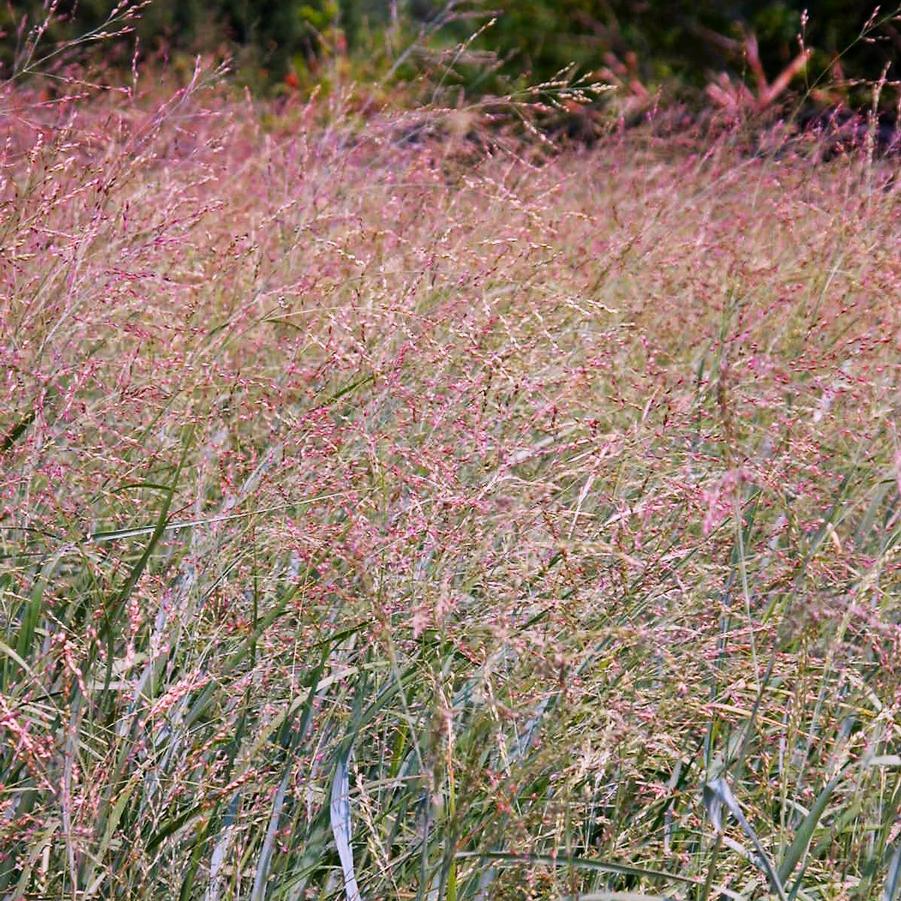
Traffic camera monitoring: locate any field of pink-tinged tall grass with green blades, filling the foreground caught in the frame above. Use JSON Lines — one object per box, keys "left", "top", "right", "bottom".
{"left": 0, "top": 79, "right": 901, "bottom": 901}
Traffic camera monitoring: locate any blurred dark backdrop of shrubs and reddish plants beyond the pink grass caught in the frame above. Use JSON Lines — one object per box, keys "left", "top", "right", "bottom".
{"left": 0, "top": 0, "right": 901, "bottom": 110}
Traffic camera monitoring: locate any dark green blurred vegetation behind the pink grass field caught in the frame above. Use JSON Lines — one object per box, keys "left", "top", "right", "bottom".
{"left": 0, "top": 0, "right": 901, "bottom": 102}
